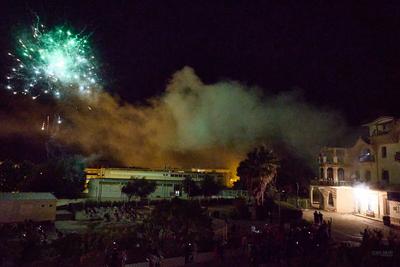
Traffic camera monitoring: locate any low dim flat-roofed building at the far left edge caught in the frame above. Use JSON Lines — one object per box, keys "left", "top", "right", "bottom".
{"left": 0, "top": 193, "right": 57, "bottom": 223}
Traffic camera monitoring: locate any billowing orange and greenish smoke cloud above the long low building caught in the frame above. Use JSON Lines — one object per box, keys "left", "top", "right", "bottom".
{"left": 0, "top": 67, "right": 344, "bottom": 173}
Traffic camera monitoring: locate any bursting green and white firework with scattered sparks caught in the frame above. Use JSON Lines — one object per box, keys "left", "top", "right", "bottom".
{"left": 6, "top": 19, "right": 99, "bottom": 99}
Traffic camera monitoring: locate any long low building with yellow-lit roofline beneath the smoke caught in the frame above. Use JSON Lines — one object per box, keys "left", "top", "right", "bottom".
{"left": 86, "top": 168, "right": 230, "bottom": 200}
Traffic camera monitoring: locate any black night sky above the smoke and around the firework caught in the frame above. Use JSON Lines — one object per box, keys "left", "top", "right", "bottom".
{"left": 0, "top": 0, "right": 400, "bottom": 161}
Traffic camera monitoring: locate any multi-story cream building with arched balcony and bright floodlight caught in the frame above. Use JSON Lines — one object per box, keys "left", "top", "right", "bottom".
{"left": 310, "top": 117, "right": 400, "bottom": 226}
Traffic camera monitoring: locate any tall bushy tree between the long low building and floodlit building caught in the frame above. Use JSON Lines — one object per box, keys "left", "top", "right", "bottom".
{"left": 237, "top": 146, "right": 279, "bottom": 205}
